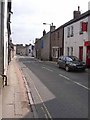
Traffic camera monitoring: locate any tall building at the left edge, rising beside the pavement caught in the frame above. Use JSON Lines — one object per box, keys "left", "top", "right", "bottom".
{"left": 0, "top": 0, "right": 12, "bottom": 75}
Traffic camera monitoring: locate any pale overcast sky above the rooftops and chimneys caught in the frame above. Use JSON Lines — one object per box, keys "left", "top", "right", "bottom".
{"left": 11, "top": 0, "right": 89, "bottom": 44}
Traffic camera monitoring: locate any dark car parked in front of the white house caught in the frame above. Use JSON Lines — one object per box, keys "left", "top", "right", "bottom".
{"left": 57, "top": 56, "right": 86, "bottom": 71}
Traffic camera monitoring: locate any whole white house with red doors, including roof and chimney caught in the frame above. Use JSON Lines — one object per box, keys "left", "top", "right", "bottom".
{"left": 64, "top": 8, "right": 90, "bottom": 67}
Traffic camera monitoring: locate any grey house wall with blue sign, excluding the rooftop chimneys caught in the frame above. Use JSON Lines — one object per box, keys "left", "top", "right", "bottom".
{"left": 35, "top": 32, "right": 50, "bottom": 60}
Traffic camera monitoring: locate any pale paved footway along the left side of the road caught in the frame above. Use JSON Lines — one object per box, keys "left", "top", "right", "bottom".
{"left": 0, "top": 58, "right": 34, "bottom": 120}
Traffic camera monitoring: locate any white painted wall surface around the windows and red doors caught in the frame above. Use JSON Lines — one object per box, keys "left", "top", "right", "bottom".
{"left": 64, "top": 17, "right": 88, "bottom": 61}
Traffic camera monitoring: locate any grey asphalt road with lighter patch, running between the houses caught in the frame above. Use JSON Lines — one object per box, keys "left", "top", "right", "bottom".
{"left": 18, "top": 57, "right": 90, "bottom": 119}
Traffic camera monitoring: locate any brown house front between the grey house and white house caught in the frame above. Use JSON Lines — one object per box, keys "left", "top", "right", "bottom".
{"left": 51, "top": 26, "right": 64, "bottom": 61}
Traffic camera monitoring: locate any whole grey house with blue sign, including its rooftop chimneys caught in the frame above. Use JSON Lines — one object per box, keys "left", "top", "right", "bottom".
{"left": 35, "top": 24, "right": 55, "bottom": 60}
